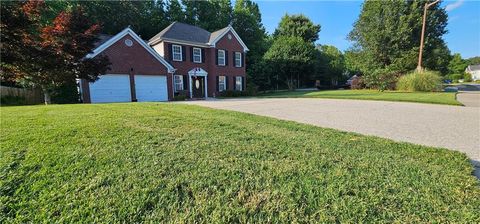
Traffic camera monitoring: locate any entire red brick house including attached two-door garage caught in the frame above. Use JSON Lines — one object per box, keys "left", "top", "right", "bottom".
{"left": 79, "top": 22, "right": 248, "bottom": 103}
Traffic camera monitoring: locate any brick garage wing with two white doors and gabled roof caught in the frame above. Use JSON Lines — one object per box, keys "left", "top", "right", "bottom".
{"left": 79, "top": 28, "right": 175, "bottom": 103}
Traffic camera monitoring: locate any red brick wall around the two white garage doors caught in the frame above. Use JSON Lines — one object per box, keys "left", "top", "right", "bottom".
{"left": 82, "top": 34, "right": 173, "bottom": 103}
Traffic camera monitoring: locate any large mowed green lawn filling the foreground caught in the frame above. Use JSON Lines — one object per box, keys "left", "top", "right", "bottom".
{"left": 0, "top": 103, "right": 480, "bottom": 223}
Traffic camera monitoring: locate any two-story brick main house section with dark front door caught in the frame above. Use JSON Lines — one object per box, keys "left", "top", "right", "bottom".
{"left": 148, "top": 22, "right": 248, "bottom": 98}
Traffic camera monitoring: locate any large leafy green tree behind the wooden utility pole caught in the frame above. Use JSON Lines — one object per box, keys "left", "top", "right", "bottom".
{"left": 348, "top": 0, "right": 450, "bottom": 79}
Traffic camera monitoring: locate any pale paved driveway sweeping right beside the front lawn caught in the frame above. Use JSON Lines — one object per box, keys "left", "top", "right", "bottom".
{"left": 186, "top": 98, "right": 480, "bottom": 172}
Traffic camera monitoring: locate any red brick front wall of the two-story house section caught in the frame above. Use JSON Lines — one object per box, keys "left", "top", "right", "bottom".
{"left": 160, "top": 29, "right": 246, "bottom": 96}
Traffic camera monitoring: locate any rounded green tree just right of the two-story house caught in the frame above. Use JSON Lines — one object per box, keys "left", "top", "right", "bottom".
{"left": 265, "top": 36, "right": 315, "bottom": 89}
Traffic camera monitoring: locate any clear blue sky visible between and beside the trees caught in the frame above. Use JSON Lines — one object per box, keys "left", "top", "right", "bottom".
{"left": 256, "top": 0, "right": 480, "bottom": 58}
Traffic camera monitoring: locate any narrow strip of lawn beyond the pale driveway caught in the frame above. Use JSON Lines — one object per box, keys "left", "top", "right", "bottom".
{"left": 260, "top": 90, "right": 462, "bottom": 105}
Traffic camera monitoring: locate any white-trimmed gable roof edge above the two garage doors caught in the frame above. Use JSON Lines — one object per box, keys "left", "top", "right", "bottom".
{"left": 86, "top": 28, "right": 175, "bottom": 72}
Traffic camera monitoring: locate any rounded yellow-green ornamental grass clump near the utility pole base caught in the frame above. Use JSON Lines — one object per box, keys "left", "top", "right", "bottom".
{"left": 397, "top": 71, "right": 442, "bottom": 92}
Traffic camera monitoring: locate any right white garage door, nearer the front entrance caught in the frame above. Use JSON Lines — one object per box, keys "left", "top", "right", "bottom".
{"left": 135, "top": 75, "right": 168, "bottom": 102}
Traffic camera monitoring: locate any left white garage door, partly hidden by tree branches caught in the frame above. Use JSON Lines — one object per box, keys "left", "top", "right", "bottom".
{"left": 90, "top": 75, "right": 132, "bottom": 103}
